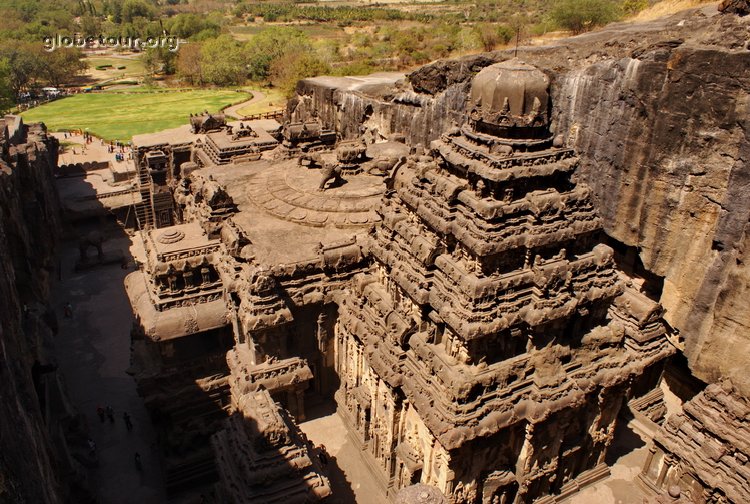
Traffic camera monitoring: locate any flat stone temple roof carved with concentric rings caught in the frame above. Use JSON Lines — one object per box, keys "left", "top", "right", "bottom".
{"left": 196, "top": 159, "right": 385, "bottom": 267}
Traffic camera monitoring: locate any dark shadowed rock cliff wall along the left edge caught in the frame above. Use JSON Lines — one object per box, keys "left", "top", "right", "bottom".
{"left": 0, "top": 121, "right": 63, "bottom": 503}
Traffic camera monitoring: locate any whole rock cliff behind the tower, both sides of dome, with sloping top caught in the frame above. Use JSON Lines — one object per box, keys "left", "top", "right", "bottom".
{"left": 298, "top": 5, "right": 750, "bottom": 395}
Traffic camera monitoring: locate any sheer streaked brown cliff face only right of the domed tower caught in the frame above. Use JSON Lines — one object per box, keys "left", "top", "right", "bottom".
{"left": 558, "top": 36, "right": 750, "bottom": 395}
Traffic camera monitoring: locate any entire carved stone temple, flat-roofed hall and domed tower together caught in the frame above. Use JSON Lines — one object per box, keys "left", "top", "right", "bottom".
{"left": 119, "top": 59, "right": 680, "bottom": 504}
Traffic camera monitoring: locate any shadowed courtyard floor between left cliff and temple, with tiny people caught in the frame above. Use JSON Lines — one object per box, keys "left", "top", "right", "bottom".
{"left": 52, "top": 236, "right": 166, "bottom": 504}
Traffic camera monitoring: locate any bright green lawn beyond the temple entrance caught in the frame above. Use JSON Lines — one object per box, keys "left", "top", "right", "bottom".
{"left": 21, "top": 90, "right": 250, "bottom": 141}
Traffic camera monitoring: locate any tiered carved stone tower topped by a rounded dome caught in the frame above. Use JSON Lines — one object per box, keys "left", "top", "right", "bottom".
{"left": 335, "top": 60, "right": 673, "bottom": 503}
